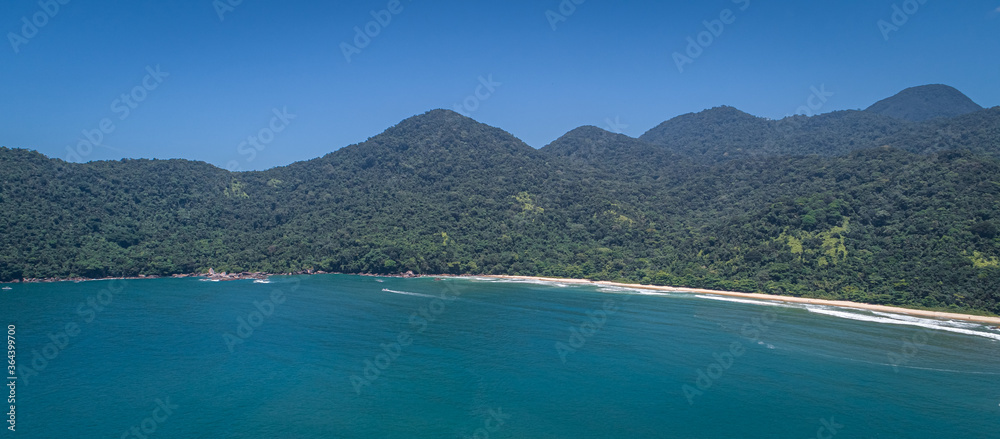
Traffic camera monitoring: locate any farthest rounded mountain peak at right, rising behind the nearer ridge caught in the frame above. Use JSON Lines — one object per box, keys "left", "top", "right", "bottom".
{"left": 865, "top": 84, "right": 983, "bottom": 122}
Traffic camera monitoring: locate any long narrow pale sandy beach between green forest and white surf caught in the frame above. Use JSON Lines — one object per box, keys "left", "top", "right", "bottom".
{"left": 482, "top": 275, "right": 1000, "bottom": 326}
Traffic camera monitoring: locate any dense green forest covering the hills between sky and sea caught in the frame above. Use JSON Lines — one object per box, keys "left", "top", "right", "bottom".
{"left": 0, "top": 86, "right": 1000, "bottom": 314}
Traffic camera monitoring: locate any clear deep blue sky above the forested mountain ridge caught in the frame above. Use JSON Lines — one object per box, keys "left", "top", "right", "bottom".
{"left": 0, "top": 0, "right": 1000, "bottom": 170}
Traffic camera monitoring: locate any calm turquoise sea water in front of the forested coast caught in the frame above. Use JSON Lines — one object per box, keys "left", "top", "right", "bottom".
{"left": 0, "top": 275, "right": 1000, "bottom": 439}
